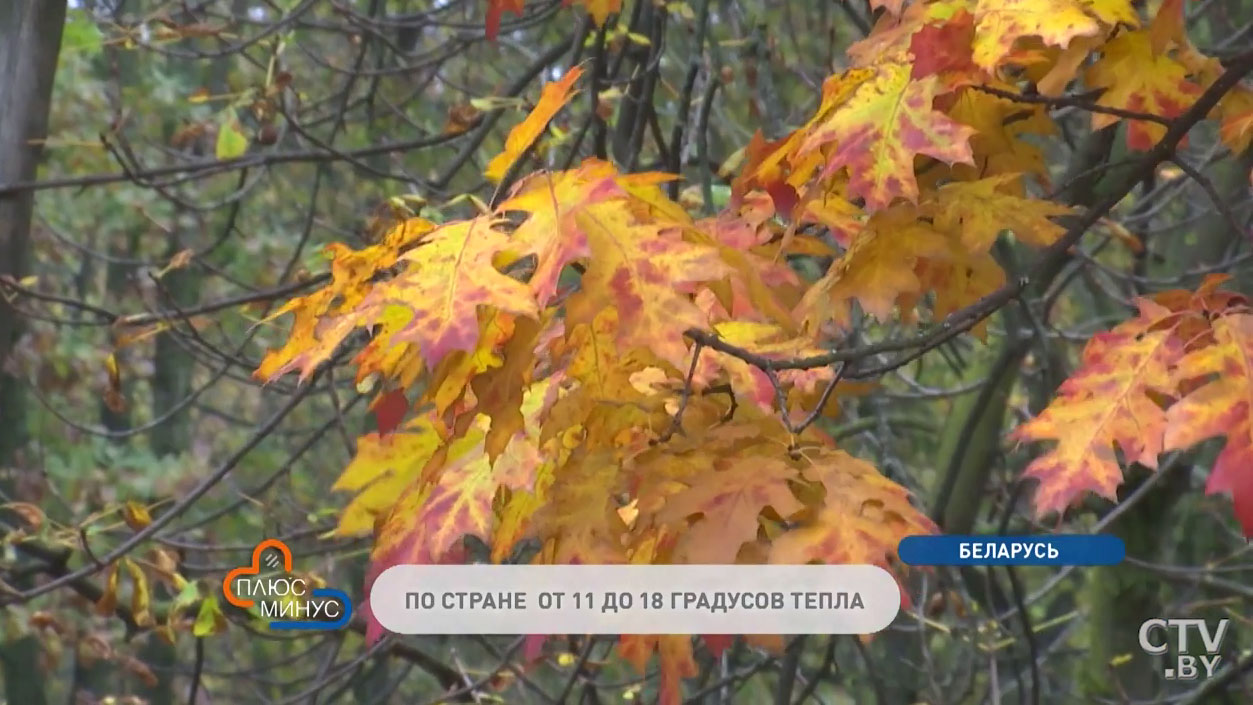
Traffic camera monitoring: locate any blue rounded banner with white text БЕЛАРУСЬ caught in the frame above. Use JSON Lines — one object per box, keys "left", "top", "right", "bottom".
{"left": 897, "top": 533, "right": 1126, "bottom": 566}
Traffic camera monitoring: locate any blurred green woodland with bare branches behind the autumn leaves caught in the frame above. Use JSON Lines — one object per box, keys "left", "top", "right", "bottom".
{"left": 0, "top": 0, "right": 1253, "bottom": 705}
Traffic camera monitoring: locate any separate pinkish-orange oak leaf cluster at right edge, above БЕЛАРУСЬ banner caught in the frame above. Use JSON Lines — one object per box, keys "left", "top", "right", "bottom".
{"left": 1015, "top": 274, "right": 1253, "bottom": 536}
